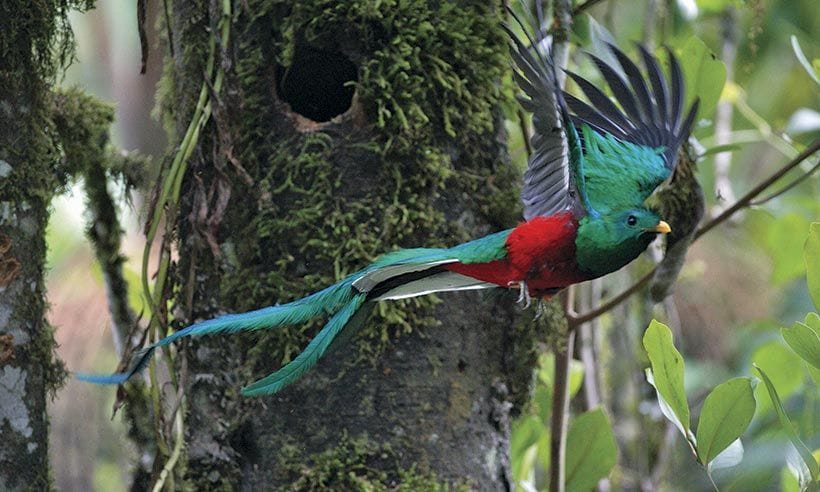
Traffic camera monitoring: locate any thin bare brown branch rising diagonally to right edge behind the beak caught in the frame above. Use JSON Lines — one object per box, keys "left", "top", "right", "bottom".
{"left": 567, "top": 139, "right": 820, "bottom": 324}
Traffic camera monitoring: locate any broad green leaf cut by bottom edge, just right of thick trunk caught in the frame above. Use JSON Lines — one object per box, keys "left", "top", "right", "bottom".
{"left": 566, "top": 408, "right": 618, "bottom": 492}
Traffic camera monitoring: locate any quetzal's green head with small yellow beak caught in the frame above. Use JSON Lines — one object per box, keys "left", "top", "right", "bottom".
{"left": 575, "top": 208, "right": 672, "bottom": 277}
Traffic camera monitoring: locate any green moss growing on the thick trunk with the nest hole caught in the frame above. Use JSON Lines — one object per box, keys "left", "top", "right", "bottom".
{"left": 161, "top": 0, "right": 532, "bottom": 484}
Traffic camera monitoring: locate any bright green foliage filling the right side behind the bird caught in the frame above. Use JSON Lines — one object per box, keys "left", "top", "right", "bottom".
{"left": 508, "top": 0, "right": 820, "bottom": 491}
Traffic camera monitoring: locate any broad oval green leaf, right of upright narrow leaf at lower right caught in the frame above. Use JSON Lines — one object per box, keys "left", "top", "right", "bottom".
{"left": 697, "top": 378, "right": 755, "bottom": 465}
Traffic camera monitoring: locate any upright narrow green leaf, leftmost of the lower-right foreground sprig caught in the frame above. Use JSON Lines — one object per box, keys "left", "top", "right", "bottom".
{"left": 643, "top": 320, "right": 692, "bottom": 439}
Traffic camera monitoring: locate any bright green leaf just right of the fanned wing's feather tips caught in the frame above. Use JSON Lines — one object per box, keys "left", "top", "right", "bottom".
{"left": 675, "top": 36, "right": 726, "bottom": 119}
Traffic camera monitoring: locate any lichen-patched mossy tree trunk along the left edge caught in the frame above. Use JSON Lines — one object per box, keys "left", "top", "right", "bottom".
{"left": 0, "top": 2, "right": 76, "bottom": 490}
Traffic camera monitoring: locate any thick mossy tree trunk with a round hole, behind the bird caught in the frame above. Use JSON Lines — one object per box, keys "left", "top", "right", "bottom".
{"left": 162, "top": 0, "right": 548, "bottom": 490}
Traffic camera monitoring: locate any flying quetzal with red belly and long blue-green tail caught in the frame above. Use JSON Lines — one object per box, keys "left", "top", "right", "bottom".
{"left": 78, "top": 17, "right": 695, "bottom": 396}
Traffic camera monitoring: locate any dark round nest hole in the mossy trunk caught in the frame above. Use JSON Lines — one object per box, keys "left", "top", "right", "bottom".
{"left": 276, "top": 44, "right": 359, "bottom": 123}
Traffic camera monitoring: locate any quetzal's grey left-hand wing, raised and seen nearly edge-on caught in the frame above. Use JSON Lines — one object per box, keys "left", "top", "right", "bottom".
{"left": 504, "top": 5, "right": 586, "bottom": 220}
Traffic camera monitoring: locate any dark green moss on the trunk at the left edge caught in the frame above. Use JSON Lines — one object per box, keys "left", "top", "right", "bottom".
{"left": 0, "top": 0, "right": 98, "bottom": 416}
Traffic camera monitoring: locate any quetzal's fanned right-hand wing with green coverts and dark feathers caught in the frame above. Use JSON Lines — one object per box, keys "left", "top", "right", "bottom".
{"left": 564, "top": 40, "right": 698, "bottom": 206}
